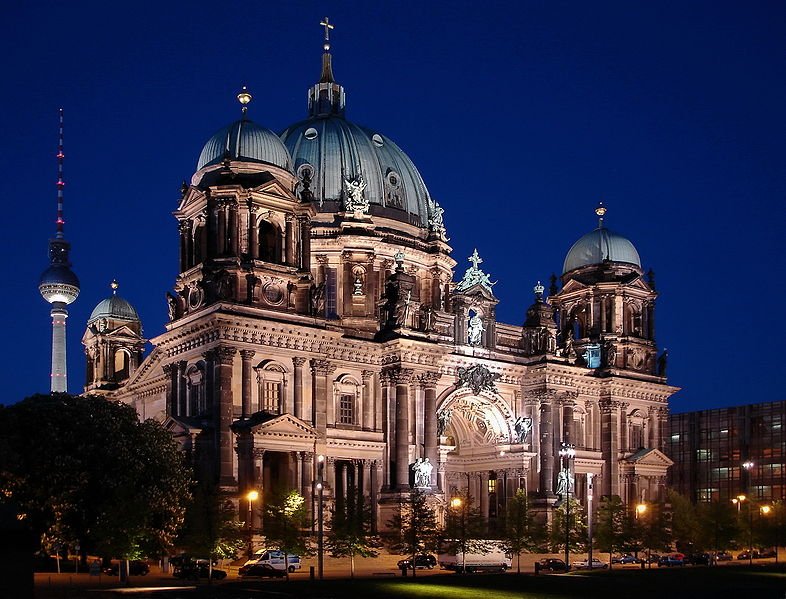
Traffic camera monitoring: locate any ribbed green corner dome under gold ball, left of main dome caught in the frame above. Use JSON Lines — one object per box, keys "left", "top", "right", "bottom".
{"left": 197, "top": 119, "right": 292, "bottom": 170}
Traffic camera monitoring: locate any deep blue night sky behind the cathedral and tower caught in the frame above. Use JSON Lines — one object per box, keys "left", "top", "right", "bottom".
{"left": 0, "top": 0, "right": 786, "bottom": 411}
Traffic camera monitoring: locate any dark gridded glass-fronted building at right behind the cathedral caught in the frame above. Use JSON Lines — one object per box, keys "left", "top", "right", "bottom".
{"left": 666, "top": 401, "right": 786, "bottom": 502}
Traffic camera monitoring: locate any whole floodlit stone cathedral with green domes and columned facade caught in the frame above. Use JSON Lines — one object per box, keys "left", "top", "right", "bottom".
{"left": 84, "top": 34, "right": 676, "bottom": 531}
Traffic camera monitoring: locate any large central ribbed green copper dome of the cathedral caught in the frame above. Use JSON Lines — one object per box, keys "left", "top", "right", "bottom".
{"left": 281, "top": 115, "right": 430, "bottom": 226}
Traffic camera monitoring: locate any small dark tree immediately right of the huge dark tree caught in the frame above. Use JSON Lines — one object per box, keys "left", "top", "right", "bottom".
{"left": 177, "top": 482, "right": 244, "bottom": 565}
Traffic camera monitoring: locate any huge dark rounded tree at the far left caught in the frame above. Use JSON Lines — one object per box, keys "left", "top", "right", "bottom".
{"left": 0, "top": 394, "right": 189, "bottom": 561}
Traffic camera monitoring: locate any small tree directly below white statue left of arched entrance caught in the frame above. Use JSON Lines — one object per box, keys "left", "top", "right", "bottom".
{"left": 387, "top": 489, "right": 439, "bottom": 577}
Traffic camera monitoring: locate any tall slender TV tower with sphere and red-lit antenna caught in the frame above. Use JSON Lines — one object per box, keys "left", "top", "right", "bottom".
{"left": 38, "top": 108, "right": 79, "bottom": 393}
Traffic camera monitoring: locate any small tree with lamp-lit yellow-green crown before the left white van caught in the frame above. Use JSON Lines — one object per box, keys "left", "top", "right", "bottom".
{"left": 264, "top": 491, "right": 310, "bottom": 579}
